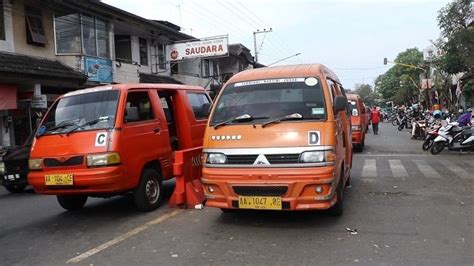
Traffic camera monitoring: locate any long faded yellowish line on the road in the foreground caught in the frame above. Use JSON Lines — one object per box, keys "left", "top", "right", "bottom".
{"left": 66, "top": 210, "right": 180, "bottom": 263}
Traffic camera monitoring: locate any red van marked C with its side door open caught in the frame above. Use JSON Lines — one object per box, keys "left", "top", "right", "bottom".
{"left": 28, "top": 84, "right": 211, "bottom": 211}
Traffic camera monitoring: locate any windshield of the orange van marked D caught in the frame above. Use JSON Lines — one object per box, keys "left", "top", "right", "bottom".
{"left": 210, "top": 78, "right": 326, "bottom": 125}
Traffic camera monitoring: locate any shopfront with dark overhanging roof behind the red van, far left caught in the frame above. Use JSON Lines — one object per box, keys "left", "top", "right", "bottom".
{"left": 0, "top": 52, "right": 87, "bottom": 148}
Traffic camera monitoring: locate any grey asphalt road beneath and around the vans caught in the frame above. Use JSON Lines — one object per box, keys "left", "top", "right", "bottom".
{"left": 0, "top": 124, "right": 474, "bottom": 265}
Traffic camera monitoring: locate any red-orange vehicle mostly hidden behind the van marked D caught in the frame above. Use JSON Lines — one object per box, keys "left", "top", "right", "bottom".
{"left": 347, "top": 94, "right": 370, "bottom": 151}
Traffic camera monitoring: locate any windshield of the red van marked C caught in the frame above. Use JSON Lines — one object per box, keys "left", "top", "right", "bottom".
{"left": 42, "top": 90, "right": 119, "bottom": 134}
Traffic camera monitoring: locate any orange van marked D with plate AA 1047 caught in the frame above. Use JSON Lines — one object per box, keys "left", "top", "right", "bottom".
{"left": 202, "top": 65, "right": 352, "bottom": 215}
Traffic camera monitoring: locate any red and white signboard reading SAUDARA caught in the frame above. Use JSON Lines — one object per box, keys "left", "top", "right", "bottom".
{"left": 166, "top": 36, "right": 229, "bottom": 62}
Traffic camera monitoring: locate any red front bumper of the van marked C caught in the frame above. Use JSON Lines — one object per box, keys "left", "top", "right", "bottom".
{"left": 28, "top": 166, "right": 129, "bottom": 195}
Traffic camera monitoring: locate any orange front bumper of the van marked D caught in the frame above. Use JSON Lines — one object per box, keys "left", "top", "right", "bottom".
{"left": 202, "top": 166, "right": 340, "bottom": 210}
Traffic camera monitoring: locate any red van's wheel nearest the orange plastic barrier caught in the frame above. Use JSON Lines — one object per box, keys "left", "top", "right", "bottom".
{"left": 133, "top": 168, "right": 163, "bottom": 212}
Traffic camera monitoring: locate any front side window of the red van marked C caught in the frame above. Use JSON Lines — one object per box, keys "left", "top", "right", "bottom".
{"left": 125, "top": 91, "right": 155, "bottom": 123}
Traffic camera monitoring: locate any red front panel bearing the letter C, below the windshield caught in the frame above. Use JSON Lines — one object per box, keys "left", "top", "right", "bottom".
{"left": 30, "top": 130, "right": 113, "bottom": 158}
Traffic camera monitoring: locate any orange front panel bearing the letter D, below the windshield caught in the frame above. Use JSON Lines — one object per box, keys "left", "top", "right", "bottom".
{"left": 203, "top": 122, "right": 335, "bottom": 149}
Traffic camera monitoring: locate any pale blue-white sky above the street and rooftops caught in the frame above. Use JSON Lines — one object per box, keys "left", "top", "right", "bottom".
{"left": 103, "top": 0, "right": 449, "bottom": 89}
